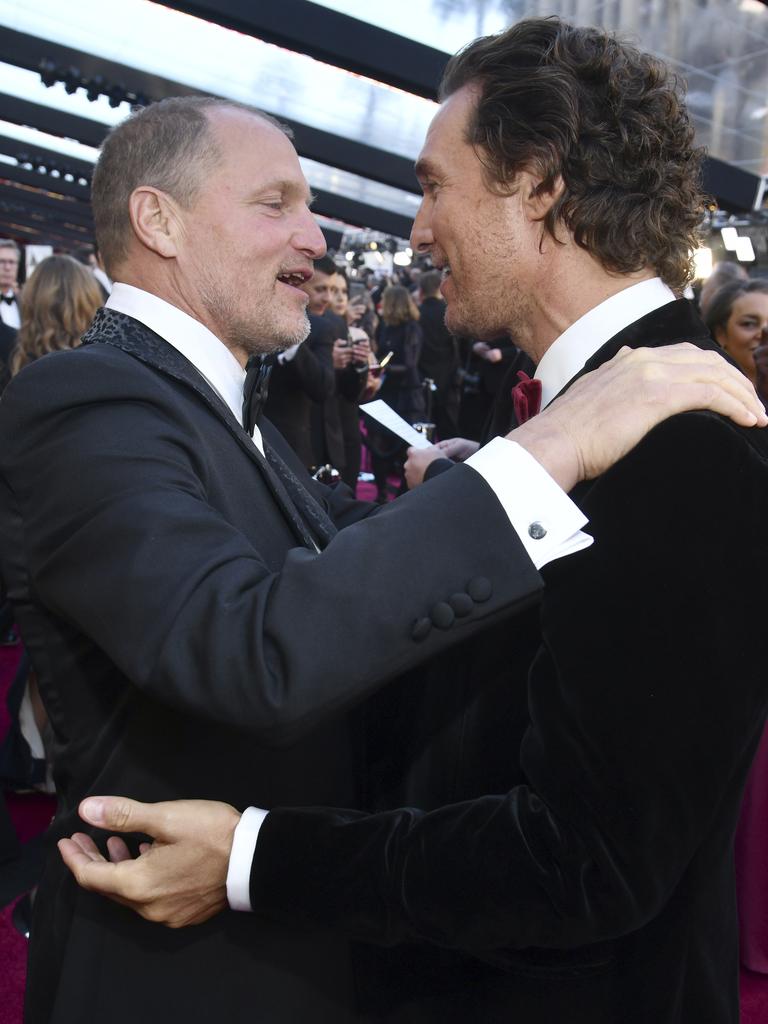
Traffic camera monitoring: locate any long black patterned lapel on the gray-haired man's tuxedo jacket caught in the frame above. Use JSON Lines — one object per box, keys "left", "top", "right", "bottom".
{"left": 83, "top": 308, "right": 316, "bottom": 551}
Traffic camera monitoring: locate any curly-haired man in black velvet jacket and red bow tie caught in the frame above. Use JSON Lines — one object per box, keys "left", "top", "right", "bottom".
{"left": 65, "top": 18, "right": 768, "bottom": 1024}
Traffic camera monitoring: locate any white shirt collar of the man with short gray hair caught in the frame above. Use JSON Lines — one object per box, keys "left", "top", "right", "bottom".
{"left": 104, "top": 282, "right": 264, "bottom": 455}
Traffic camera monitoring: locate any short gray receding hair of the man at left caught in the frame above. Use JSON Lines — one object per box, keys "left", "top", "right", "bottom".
{"left": 91, "top": 96, "right": 292, "bottom": 276}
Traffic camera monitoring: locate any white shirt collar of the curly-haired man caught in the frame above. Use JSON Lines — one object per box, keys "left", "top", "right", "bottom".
{"left": 534, "top": 278, "right": 675, "bottom": 409}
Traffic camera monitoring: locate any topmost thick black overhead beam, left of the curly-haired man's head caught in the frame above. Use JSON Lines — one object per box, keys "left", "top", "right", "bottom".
{"left": 156, "top": 0, "right": 449, "bottom": 99}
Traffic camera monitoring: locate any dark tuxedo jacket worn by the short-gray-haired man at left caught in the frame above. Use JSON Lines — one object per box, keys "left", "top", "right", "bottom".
{"left": 0, "top": 310, "right": 541, "bottom": 1024}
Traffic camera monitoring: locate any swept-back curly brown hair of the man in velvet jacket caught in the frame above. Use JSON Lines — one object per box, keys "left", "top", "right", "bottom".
{"left": 440, "top": 17, "right": 706, "bottom": 291}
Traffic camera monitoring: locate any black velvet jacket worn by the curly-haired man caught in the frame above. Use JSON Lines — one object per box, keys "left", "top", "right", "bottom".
{"left": 251, "top": 301, "right": 768, "bottom": 1024}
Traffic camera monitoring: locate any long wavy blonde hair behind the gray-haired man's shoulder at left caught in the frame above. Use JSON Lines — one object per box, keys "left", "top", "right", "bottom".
{"left": 10, "top": 256, "right": 102, "bottom": 376}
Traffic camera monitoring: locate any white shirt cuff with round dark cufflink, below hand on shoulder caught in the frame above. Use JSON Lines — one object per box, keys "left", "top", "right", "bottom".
{"left": 464, "top": 437, "right": 593, "bottom": 569}
